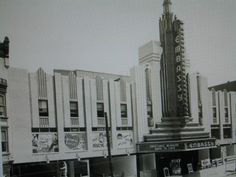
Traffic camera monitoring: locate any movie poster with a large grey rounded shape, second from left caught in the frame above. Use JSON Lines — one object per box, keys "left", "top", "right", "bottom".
{"left": 65, "top": 133, "right": 87, "bottom": 151}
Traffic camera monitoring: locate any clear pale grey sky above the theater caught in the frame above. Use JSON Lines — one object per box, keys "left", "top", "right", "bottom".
{"left": 0, "top": 0, "right": 236, "bottom": 86}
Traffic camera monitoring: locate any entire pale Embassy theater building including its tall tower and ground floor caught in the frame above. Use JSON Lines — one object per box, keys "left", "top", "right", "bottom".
{"left": 0, "top": 0, "right": 236, "bottom": 177}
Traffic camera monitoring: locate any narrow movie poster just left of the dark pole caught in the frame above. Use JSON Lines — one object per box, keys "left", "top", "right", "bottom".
{"left": 92, "top": 131, "right": 107, "bottom": 150}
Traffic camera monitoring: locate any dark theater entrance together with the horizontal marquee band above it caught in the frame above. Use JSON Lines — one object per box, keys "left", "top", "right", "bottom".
{"left": 137, "top": 138, "right": 215, "bottom": 177}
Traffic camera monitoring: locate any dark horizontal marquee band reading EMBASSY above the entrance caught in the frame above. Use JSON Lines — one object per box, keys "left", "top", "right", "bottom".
{"left": 137, "top": 139, "right": 215, "bottom": 152}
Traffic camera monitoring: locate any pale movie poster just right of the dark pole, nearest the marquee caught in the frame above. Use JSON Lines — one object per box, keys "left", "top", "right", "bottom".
{"left": 116, "top": 131, "right": 133, "bottom": 148}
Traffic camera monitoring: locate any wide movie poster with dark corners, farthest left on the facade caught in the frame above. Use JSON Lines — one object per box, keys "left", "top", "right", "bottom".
{"left": 32, "top": 133, "right": 59, "bottom": 153}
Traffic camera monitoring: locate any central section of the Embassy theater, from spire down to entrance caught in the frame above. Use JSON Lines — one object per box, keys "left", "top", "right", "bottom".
{"left": 134, "top": 0, "right": 216, "bottom": 176}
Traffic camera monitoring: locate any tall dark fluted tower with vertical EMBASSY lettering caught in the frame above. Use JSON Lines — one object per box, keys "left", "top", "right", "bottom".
{"left": 159, "top": 0, "right": 190, "bottom": 119}
